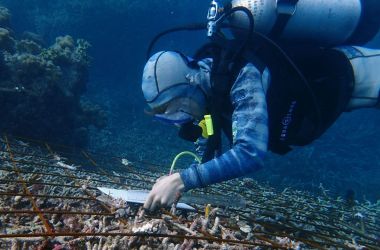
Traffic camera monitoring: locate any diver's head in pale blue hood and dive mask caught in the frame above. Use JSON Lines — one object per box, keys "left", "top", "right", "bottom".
{"left": 142, "top": 51, "right": 206, "bottom": 125}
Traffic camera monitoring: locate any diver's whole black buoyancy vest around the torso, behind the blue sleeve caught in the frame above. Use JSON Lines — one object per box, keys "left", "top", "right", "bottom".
{"left": 198, "top": 34, "right": 354, "bottom": 162}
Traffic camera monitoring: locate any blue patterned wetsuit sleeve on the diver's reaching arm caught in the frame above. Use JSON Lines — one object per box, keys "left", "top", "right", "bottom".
{"left": 181, "top": 64, "right": 268, "bottom": 191}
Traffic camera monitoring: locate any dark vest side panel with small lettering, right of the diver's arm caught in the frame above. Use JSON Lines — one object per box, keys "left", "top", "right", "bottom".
{"left": 248, "top": 33, "right": 321, "bottom": 154}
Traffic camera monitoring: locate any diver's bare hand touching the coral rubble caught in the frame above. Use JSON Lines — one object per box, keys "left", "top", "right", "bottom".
{"left": 144, "top": 173, "right": 185, "bottom": 211}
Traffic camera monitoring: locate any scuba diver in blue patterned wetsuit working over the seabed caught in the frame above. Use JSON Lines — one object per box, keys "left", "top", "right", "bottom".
{"left": 142, "top": 0, "right": 380, "bottom": 210}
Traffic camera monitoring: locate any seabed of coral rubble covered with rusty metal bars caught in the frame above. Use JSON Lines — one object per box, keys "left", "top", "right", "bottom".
{"left": 0, "top": 135, "right": 380, "bottom": 250}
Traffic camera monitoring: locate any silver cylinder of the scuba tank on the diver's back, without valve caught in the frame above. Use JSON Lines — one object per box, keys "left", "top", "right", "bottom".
{"left": 229, "top": 0, "right": 380, "bottom": 47}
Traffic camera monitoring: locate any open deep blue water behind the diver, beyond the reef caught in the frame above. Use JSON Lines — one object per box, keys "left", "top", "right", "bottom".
{"left": 0, "top": 0, "right": 380, "bottom": 200}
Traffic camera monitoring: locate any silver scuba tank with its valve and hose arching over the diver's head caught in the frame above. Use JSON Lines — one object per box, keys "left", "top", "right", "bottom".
{"left": 147, "top": 0, "right": 380, "bottom": 59}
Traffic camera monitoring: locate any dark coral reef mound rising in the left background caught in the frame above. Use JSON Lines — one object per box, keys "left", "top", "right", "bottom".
{"left": 0, "top": 7, "right": 106, "bottom": 146}
